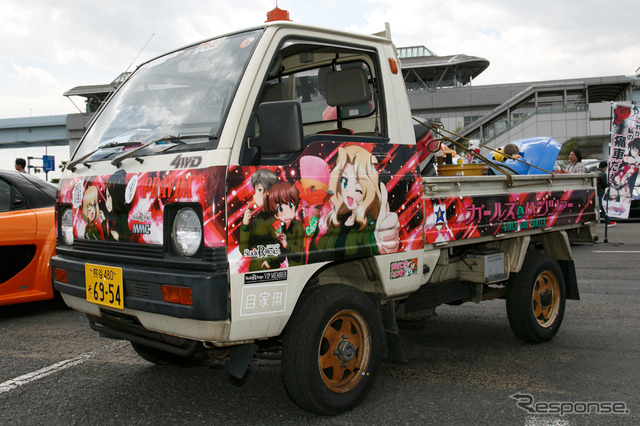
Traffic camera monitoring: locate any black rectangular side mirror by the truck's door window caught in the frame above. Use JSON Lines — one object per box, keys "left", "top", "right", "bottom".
{"left": 250, "top": 101, "right": 304, "bottom": 155}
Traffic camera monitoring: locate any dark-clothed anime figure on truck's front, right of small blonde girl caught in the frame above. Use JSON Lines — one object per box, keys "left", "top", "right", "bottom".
{"left": 100, "top": 170, "right": 131, "bottom": 241}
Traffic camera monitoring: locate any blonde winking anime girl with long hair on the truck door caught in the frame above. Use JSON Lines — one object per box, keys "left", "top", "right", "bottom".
{"left": 312, "top": 145, "right": 400, "bottom": 261}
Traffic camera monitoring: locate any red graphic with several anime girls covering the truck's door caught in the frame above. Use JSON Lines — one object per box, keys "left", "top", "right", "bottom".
{"left": 227, "top": 141, "right": 422, "bottom": 273}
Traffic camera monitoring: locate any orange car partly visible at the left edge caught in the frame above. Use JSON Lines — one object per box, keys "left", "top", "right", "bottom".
{"left": 0, "top": 170, "right": 56, "bottom": 306}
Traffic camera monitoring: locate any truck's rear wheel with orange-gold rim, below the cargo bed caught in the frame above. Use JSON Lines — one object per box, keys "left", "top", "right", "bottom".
{"left": 507, "top": 253, "right": 566, "bottom": 343}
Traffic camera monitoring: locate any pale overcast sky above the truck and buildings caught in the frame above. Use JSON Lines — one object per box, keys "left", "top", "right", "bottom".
{"left": 0, "top": 0, "right": 640, "bottom": 175}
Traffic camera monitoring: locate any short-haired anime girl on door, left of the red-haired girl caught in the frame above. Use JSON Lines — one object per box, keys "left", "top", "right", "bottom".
{"left": 238, "top": 169, "right": 280, "bottom": 271}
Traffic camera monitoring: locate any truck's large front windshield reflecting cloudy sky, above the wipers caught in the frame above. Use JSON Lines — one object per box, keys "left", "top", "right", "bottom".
{"left": 74, "top": 30, "right": 261, "bottom": 161}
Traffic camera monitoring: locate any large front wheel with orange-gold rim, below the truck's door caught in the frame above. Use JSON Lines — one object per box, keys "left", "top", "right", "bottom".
{"left": 281, "top": 284, "right": 383, "bottom": 415}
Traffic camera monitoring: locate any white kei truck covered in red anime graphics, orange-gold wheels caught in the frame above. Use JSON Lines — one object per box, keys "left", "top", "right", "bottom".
{"left": 51, "top": 22, "right": 598, "bottom": 415}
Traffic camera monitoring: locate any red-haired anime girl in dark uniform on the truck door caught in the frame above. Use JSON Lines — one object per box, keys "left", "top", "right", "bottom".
{"left": 265, "top": 182, "right": 304, "bottom": 266}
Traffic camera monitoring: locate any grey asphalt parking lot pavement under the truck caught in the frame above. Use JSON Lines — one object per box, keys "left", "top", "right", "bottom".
{"left": 0, "top": 222, "right": 640, "bottom": 425}
